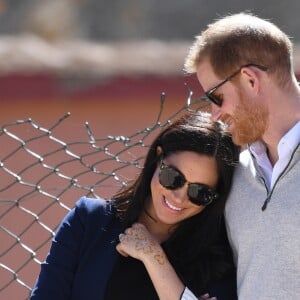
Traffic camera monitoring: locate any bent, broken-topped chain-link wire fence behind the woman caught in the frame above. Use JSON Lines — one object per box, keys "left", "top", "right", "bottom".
{"left": 0, "top": 90, "right": 207, "bottom": 299}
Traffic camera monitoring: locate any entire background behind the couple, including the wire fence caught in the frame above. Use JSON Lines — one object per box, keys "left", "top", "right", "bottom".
{"left": 0, "top": 0, "right": 300, "bottom": 300}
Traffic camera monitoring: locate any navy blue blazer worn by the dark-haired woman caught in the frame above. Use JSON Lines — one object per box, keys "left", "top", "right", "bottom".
{"left": 30, "top": 197, "right": 236, "bottom": 300}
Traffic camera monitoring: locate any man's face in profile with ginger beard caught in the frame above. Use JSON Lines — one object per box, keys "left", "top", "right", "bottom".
{"left": 197, "top": 61, "right": 268, "bottom": 145}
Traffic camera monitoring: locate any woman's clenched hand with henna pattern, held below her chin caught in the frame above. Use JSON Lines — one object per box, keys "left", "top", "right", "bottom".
{"left": 116, "top": 223, "right": 165, "bottom": 264}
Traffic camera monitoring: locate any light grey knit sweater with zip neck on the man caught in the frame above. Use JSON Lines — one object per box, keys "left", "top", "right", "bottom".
{"left": 225, "top": 145, "right": 300, "bottom": 300}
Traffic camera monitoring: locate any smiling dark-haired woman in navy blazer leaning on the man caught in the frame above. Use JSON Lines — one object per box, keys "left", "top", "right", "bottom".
{"left": 31, "top": 112, "right": 239, "bottom": 300}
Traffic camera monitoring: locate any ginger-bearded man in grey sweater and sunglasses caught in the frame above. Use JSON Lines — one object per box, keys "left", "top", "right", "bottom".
{"left": 185, "top": 13, "right": 300, "bottom": 300}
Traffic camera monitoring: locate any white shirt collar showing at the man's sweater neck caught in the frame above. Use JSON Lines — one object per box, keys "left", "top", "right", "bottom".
{"left": 250, "top": 121, "right": 300, "bottom": 189}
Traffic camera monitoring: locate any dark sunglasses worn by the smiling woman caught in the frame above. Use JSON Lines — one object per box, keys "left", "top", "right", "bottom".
{"left": 158, "top": 160, "right": 218, "bottom": 206}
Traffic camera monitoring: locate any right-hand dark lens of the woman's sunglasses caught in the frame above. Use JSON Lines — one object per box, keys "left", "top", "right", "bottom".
{"left": 188, "top": 183, "right": 217, "bottom": 206}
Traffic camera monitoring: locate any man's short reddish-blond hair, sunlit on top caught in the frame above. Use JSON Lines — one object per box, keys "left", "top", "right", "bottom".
{"left": 184, "top": 13, "right": 293, "bottom": 85}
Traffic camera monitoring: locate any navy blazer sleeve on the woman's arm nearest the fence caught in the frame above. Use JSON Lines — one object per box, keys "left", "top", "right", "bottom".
{"left": 30, "top": 197, "right": 112, "bottom": 300}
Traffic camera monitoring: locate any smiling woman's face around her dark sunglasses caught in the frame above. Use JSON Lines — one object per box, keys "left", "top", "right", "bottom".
{"left": 147, "top": 151, "right": 218, "bottom": 229}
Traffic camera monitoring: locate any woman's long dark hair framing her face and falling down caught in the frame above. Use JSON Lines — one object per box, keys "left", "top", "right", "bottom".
{"left": 113, "top": 112, "right": 239, "bottom": 293}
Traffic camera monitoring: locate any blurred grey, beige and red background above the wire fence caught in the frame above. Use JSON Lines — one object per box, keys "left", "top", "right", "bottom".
{"left": 0, "top": 0, "right": 300, "bottom": 127}
